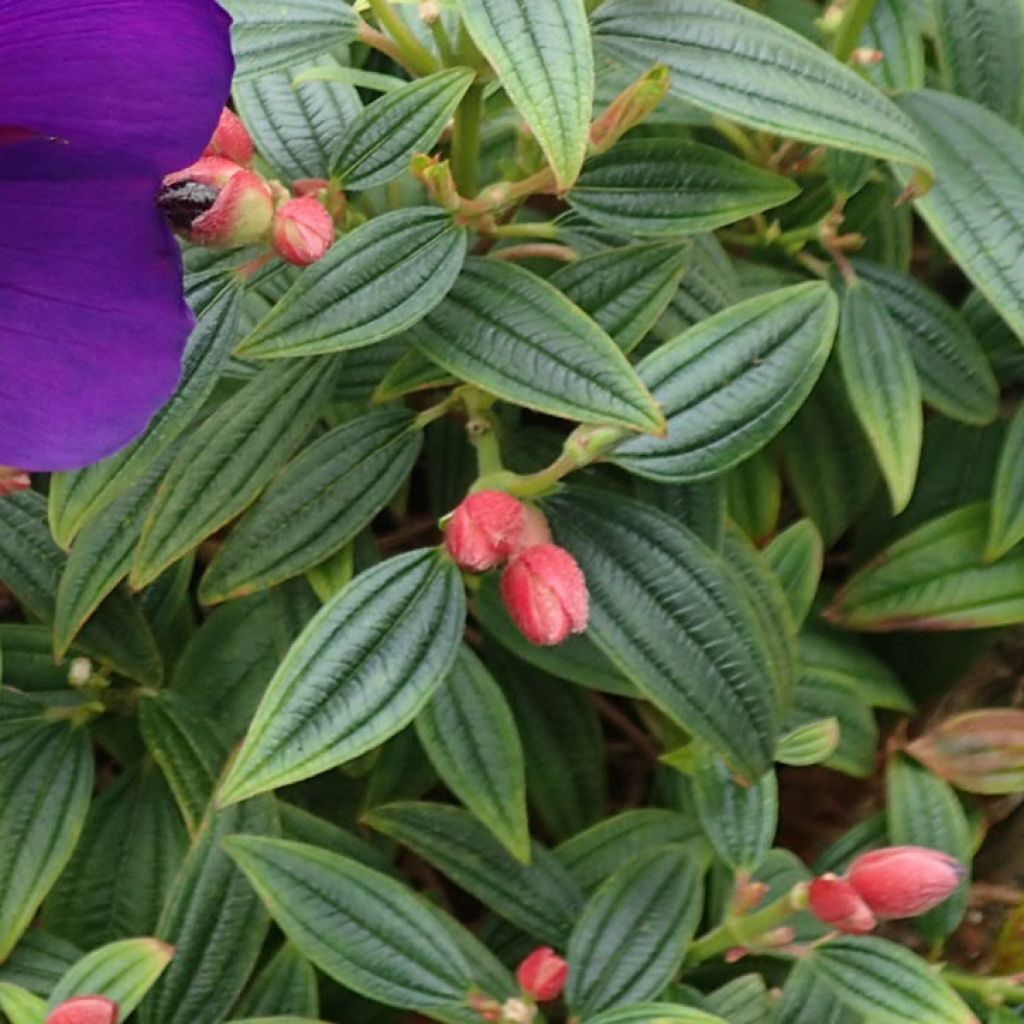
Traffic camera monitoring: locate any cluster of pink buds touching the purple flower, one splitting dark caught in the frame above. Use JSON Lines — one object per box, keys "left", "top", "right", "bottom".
{"left": 157, "top": 110, "right": 344, "bottom": 266}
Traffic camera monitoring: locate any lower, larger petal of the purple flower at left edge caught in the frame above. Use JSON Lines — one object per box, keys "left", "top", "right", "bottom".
{"left": 0, "top": 139, "right": 191, "bottom": 470}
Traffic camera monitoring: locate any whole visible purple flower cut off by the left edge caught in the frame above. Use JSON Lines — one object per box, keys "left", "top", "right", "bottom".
{"left": 0, "top": 0, "right": 233, "bottom": 470}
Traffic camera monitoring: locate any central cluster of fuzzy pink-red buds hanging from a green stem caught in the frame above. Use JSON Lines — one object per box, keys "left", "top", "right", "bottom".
{"left": 445, "top": 490, "right": 589, "bottom": 647}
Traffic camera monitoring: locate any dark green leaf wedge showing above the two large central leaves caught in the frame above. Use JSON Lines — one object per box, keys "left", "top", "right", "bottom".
{"left": 549, "top": 242, "right": 692, "bottom": 352}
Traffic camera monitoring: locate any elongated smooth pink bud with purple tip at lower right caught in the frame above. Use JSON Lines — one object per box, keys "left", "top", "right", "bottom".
{"left": 847, "top": 846, "right": 965, "bottom": 919}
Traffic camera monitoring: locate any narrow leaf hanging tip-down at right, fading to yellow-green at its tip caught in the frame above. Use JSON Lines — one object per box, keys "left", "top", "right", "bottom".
{"left": 837, "top": 282, "right": 925, "bottom": 515}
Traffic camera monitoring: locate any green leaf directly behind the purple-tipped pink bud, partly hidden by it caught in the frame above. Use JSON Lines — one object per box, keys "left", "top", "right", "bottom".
{"left": 886, "top": 754, "right": 974, "bottom": 942}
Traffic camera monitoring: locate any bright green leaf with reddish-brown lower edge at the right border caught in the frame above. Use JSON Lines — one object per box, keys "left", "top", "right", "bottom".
{"left": 828, "top": 504, "right": 1024, "bottom": 632}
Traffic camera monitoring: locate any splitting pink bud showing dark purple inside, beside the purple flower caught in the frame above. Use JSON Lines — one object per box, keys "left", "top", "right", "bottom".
{"left": 157, "top": 157, "right": 273, "bottom": 249}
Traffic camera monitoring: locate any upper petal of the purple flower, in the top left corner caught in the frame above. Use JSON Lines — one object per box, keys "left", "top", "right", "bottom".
{"left": 0, "top": 0, "right": 233, "bottom": 174}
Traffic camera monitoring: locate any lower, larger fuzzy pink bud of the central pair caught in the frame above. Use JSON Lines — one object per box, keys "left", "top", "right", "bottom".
{"left": 502, "top": 544, "right": 589, "bottom": 647}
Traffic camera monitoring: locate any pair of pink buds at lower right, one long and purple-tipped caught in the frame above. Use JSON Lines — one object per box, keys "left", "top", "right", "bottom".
{"left": 809, "top": 846, "right": 965, "bottom": 935}
